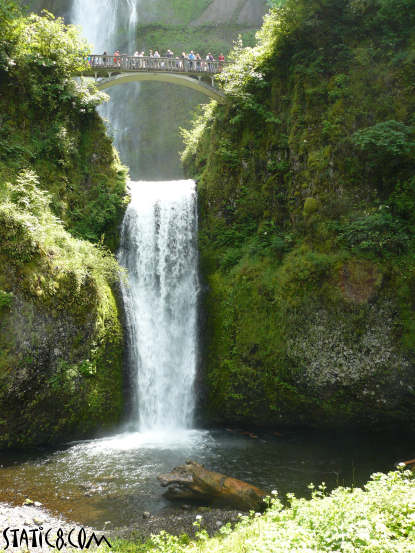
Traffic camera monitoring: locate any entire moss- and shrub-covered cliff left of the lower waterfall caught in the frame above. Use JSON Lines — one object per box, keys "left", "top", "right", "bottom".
{"left": 0, "top": 9, "right": 127, "bottom": 448}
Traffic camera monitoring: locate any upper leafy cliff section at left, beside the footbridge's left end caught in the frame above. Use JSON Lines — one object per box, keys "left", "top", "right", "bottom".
{"left": 0, "top": 8, "right": 126, "bottom": 248}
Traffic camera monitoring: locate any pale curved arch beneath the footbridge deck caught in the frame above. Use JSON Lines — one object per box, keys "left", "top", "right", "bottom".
{"left": 96, "top": 71, "right": 226, "bottom": 103}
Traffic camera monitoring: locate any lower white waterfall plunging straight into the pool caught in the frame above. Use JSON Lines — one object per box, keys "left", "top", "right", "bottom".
{"left": 119, "top": 180, "right": 198, "bottom": 431}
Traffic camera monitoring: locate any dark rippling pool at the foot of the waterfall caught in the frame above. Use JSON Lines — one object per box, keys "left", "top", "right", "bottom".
{"left": 0, "top": 430, "right": 413, "bottom": 528}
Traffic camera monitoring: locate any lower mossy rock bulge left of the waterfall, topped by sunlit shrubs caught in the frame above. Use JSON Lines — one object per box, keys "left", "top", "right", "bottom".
{"left": 0, "top": 166, "right": 123, "bottom": 447}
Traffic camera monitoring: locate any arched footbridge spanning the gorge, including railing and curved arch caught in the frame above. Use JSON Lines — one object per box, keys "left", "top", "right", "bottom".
{"left": 81, "top": 55, "right": 227, "bottom": 103}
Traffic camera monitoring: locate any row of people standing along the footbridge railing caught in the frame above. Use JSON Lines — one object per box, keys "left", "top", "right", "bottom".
{"left": 88, "top": 49, "right": 225, "bottom": 73}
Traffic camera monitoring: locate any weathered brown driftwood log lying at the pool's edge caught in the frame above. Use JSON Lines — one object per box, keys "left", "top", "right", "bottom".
{"left": 158, "top": 461, "right": 267, "bottom": 511}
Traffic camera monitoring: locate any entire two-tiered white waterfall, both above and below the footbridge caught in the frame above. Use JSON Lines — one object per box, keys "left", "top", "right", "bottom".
{"left": 72, "top": 0, "right": 198, "bottom": 432}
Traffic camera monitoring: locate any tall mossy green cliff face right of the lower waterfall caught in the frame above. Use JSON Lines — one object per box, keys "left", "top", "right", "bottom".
{"left": 185, "top": 0, "right": 415, "bottom": 427}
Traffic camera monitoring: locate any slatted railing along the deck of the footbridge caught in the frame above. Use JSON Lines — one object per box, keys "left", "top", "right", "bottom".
{"left": 88, "top": 54, "right": 228, "bottom": 75}
